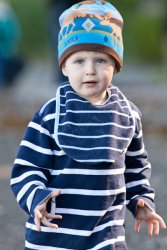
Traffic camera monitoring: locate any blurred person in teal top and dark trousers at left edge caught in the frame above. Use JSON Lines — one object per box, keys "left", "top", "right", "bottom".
{"left": 0, "top": 1, "right": 23, "bottom": 87}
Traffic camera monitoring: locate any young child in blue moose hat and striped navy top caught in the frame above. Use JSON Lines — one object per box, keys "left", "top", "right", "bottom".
{"left": 11, "top": 1, "right": 166, "bottom": 250}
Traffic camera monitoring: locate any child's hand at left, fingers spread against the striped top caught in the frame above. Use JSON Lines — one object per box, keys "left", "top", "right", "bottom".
{"left": 34, "top": 191, "right": 62, "bottom": 232}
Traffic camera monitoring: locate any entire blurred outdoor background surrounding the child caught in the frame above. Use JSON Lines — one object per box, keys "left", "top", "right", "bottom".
{"left": 0, "top": 0, "right": 167, "bottom": 250}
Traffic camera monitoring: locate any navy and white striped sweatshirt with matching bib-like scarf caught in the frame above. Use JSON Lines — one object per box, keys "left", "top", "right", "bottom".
{"left": 11, "top": 83, "right": 154, "bottom": 250}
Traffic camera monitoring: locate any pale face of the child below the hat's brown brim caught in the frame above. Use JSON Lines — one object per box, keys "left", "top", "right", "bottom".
{"left": 62, "top": 51, "right": 115, "bottom": 104}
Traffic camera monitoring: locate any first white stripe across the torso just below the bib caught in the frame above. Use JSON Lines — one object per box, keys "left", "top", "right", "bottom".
{"left": 51, "top": 168, "right": 125, "bottom": 176}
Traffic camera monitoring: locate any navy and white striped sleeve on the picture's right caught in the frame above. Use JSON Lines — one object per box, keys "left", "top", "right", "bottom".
{"left": 125, "top": 109, "right": 155, "bottom": 217}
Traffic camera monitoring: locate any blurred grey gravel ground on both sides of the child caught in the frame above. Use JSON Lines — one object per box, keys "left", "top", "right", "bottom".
{"left": 0, "top": 61, "right": 167, "bottom": 250}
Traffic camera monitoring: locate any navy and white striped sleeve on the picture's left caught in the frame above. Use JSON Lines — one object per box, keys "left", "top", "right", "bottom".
{"left": 11, "top": 109, "right": 55, "bottom": 216}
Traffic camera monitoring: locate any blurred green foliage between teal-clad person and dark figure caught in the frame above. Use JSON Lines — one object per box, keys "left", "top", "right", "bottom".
{"left": 8, "top": 0, "right": 48, "bottom": 57}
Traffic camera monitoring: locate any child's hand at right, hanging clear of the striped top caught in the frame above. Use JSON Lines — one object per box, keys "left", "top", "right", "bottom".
{"left": 135, "top": 199, "right": 166, "bottom": 236}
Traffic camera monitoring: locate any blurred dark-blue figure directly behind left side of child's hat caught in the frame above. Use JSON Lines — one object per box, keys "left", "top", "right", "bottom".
{"left": 45, "top": 0, "right": 80, "bottom": 84}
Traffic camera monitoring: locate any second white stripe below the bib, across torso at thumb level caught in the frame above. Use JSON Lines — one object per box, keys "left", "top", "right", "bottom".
{"left": 57, "top": 187, "right": 126, "bottom": 196}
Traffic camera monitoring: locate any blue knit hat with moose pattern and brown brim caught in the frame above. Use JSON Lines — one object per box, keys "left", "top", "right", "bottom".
{"left": 58, "top": 0, "right": 123, "bottom": 72}
